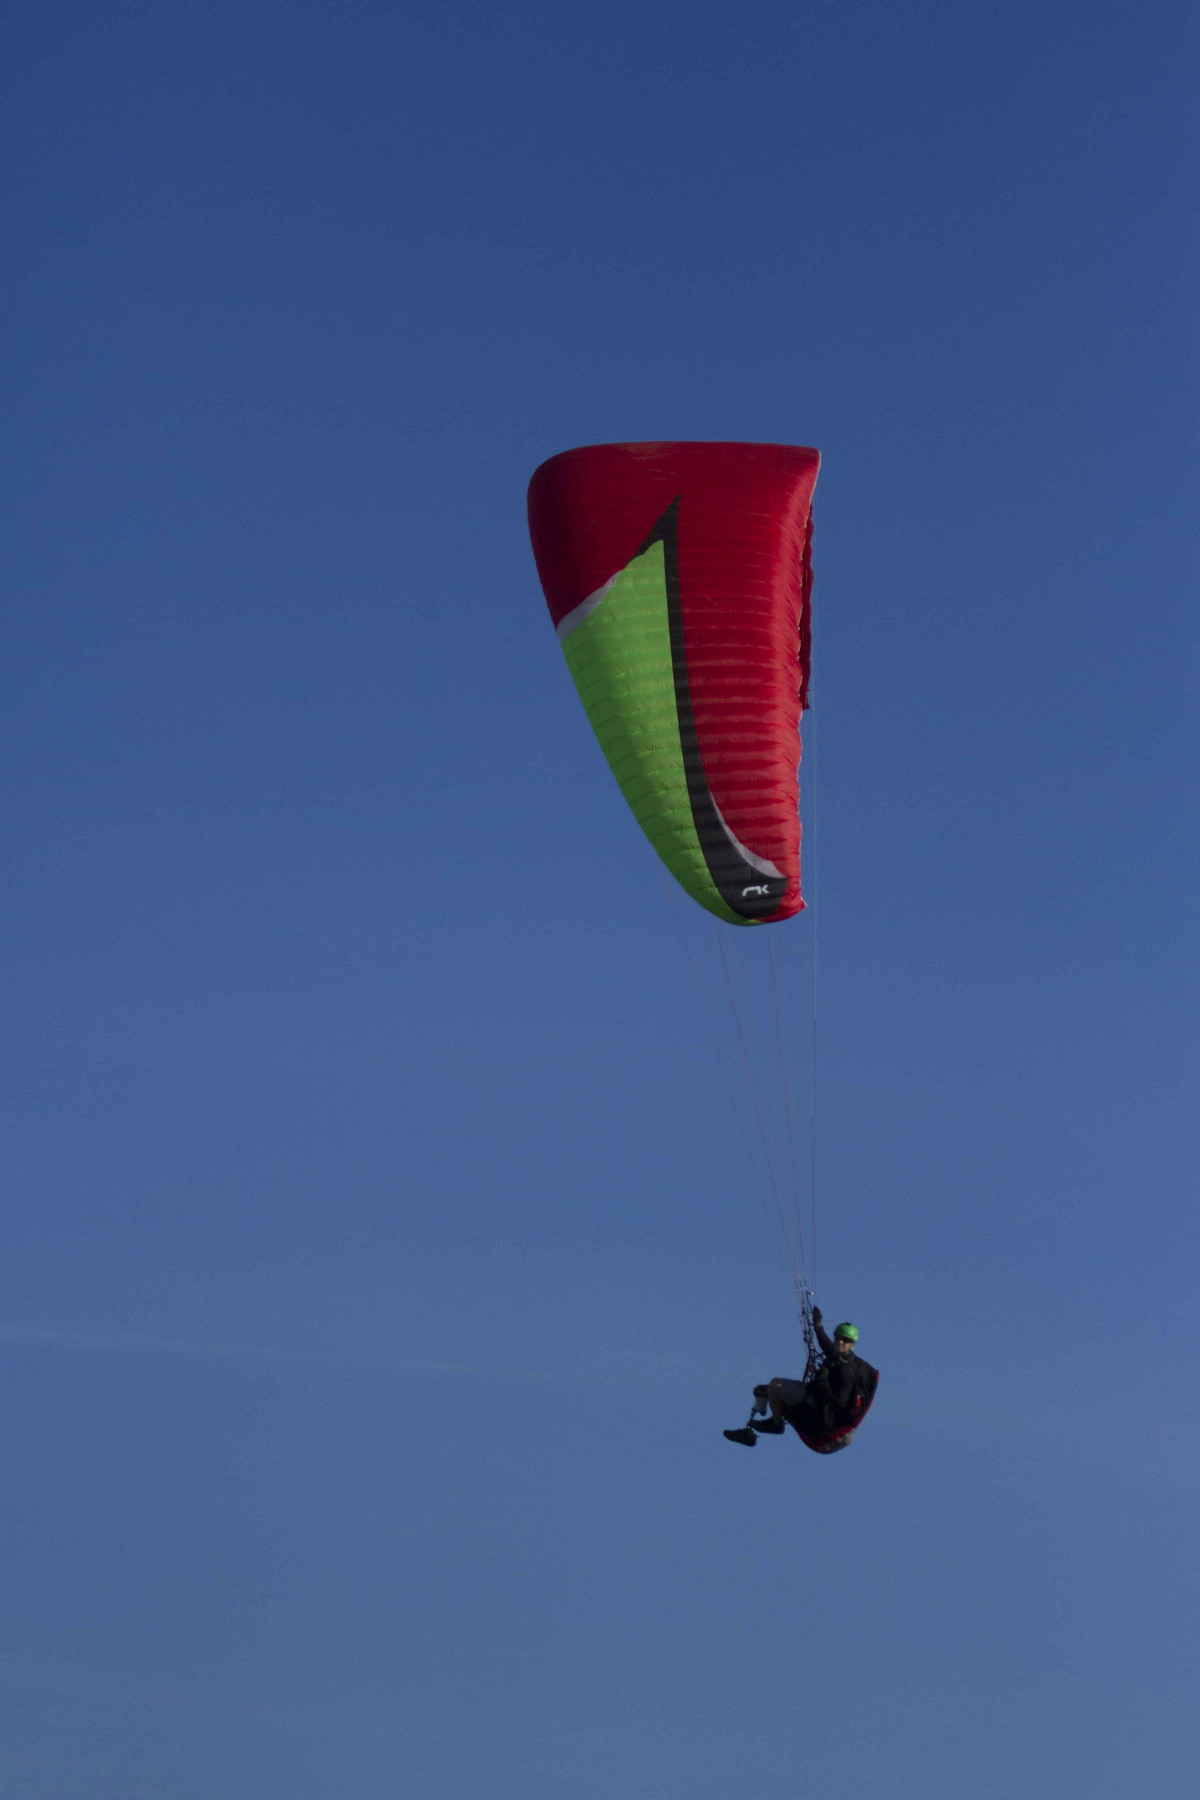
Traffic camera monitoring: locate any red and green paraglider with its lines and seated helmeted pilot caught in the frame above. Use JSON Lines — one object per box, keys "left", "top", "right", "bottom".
{"left": 529, "top": 443, "right": 878, "bottom": 1453}
